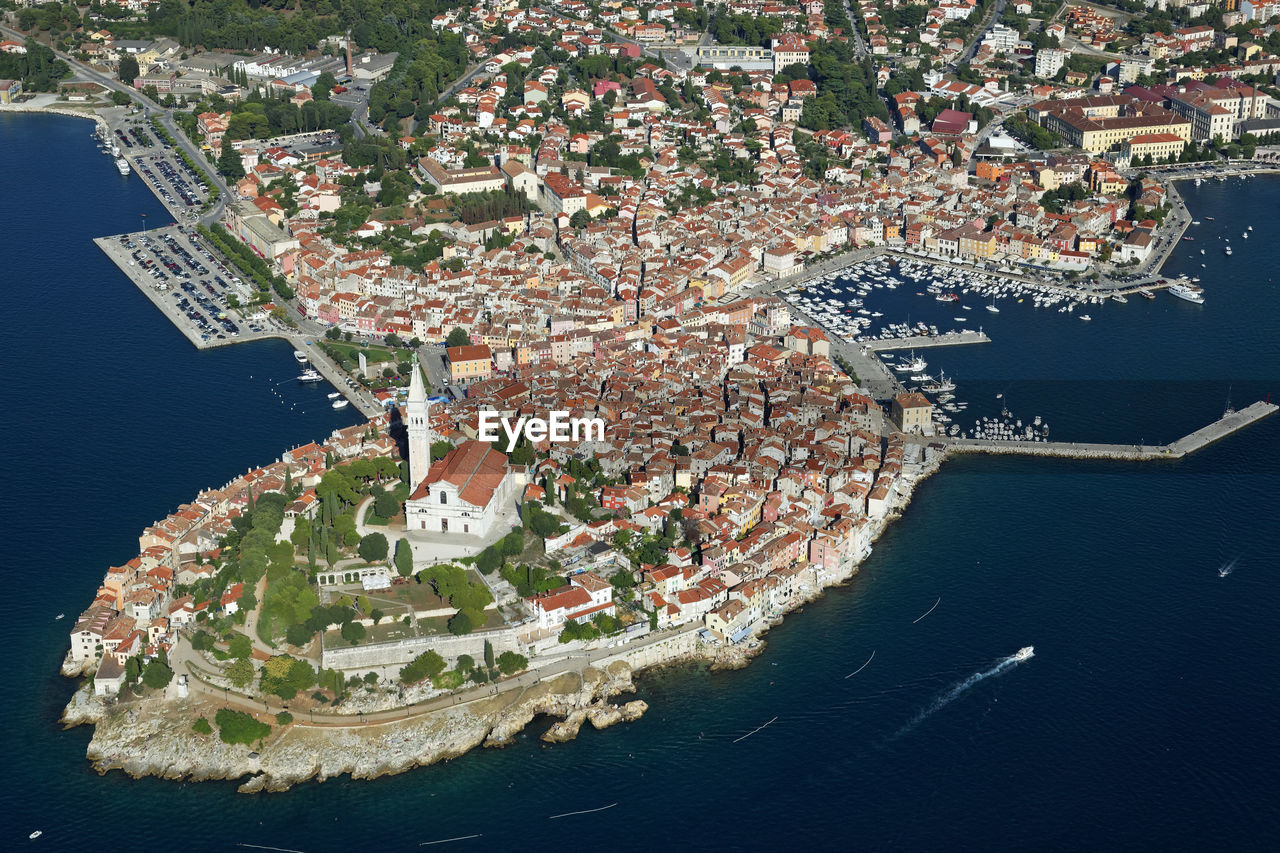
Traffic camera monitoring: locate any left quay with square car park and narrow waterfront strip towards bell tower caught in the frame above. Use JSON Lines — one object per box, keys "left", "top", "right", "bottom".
{"left": 93, "top": 225, "right": 384, "bottom": 418}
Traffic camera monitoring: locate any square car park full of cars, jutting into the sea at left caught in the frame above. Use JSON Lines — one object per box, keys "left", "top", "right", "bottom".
{"left": 110, "top": 228, "right": 276, "bottom": 345}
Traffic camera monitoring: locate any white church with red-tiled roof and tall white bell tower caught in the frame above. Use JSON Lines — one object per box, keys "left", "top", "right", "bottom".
{"left": 404, "top": 364, "right": 521, "bottom": 538}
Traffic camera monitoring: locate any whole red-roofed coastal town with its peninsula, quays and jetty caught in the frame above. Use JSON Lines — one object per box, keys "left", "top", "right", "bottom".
{"left": 0, "top": 0, "right": 1280, "bottom": 785}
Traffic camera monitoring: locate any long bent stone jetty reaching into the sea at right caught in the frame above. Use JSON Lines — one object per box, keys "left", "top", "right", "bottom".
{"left": 908, "top": 400, "right": 1280, "bottom": 461}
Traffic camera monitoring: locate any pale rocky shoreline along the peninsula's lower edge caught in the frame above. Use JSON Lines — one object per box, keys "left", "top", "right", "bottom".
{"left": 61, "top": 452, "right": 946, "bottom": 793}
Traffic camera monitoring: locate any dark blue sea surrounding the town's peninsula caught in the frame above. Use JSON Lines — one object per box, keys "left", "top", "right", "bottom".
{"left": 0, "top": 115, "right": 1280, "bottom": 853}
